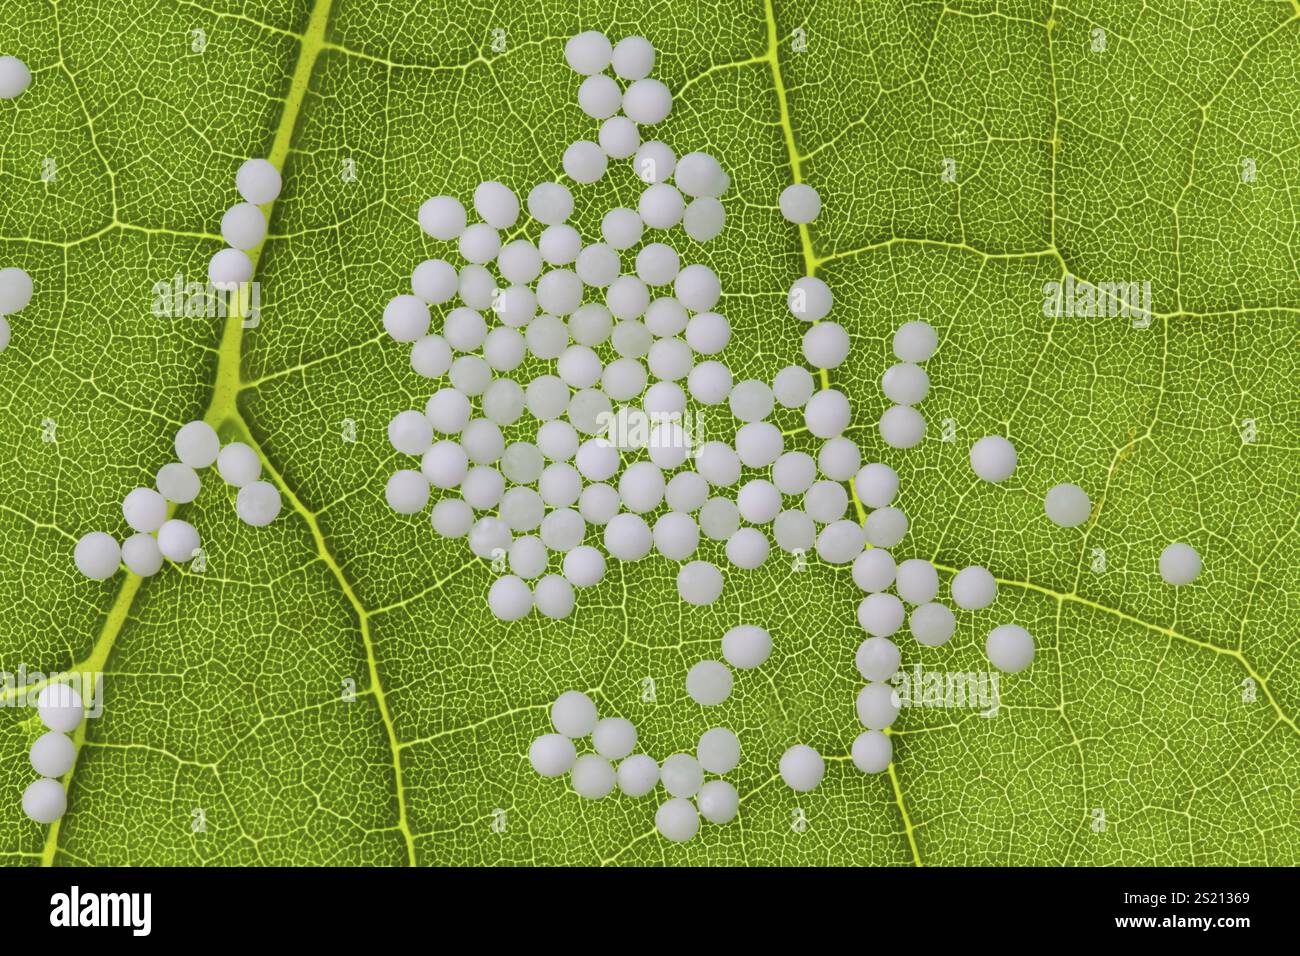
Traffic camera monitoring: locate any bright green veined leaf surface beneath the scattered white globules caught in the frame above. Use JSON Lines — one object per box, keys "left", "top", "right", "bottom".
{"left": 0, "top": 0, "right": 1300, "bottom": 865}
